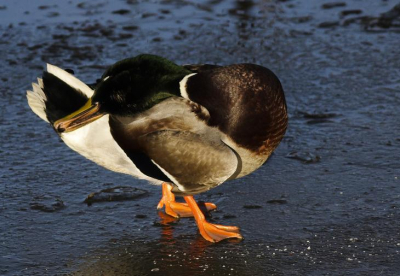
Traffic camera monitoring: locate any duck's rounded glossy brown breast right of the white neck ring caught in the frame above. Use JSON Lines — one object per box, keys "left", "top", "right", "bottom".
{"left": 184, "top": 64, "right": 288, "bottom": 176}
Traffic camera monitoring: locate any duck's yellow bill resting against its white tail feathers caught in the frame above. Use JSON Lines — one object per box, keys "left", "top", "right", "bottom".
{"left": 53, "top": 99, "right": 104, "bottom": 133}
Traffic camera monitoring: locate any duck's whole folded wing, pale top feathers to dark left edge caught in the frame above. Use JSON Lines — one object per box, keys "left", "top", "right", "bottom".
{"left": 110, "top": 97, "right": 241, "bottom": 195}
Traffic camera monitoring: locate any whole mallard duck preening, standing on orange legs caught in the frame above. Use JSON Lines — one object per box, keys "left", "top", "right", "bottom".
{"left": 27, "top": 54, "right": 288, "bottom": 242}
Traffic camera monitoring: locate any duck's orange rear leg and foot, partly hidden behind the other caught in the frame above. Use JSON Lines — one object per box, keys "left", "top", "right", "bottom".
{"left": 157, "top": 182, "right": 217, "bottom": 218}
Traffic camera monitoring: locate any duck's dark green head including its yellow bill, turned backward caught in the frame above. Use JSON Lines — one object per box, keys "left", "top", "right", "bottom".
{"left": 54, "top": 55, "right": 190, "bottom": 132}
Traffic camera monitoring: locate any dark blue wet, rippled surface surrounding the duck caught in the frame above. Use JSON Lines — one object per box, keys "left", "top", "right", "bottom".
{"left": 0, "top": 0, "right": 400, "bottom": 275}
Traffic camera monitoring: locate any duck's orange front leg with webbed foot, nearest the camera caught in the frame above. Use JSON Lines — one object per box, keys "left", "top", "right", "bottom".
{"left": 184, "top": 196, "right": 243, "bottom": 242}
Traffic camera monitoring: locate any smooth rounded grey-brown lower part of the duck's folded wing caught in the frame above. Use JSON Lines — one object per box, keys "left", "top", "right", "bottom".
{"left": 139, "top": 130, "right": 238, "bottom": 194}
